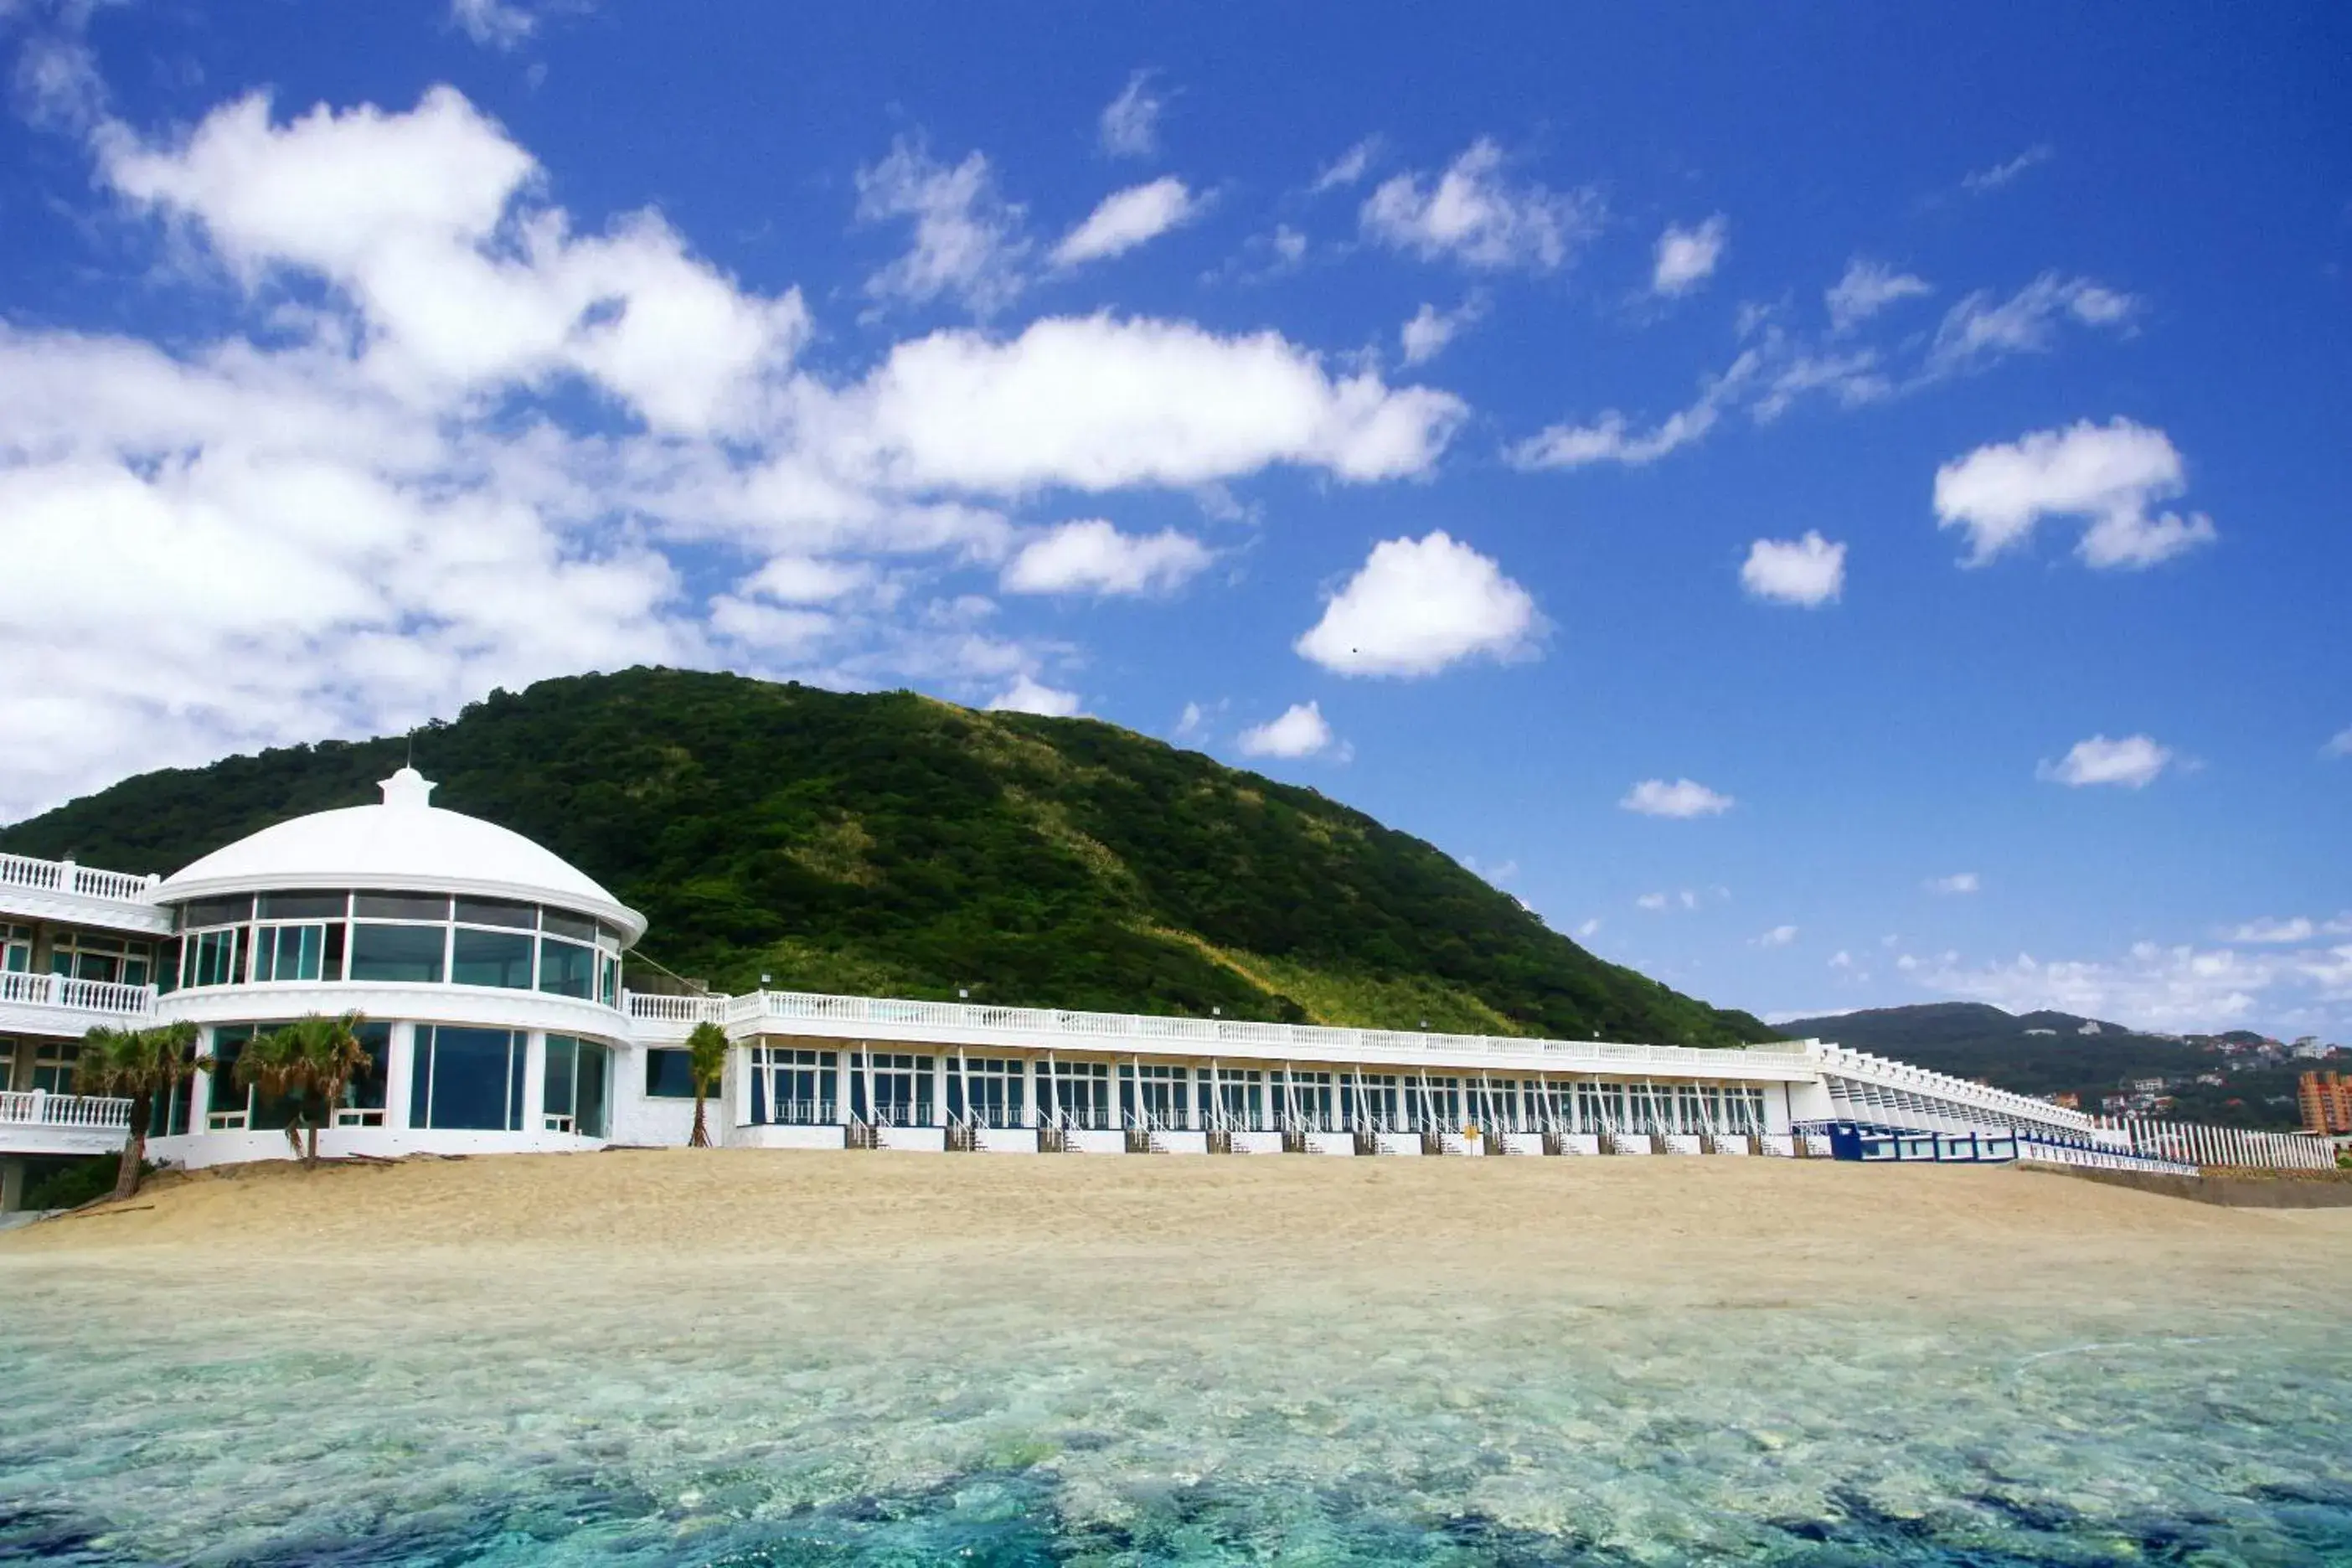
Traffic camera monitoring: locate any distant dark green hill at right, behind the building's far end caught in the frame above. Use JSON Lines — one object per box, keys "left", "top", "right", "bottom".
{"left": 1781, "top": 1002, "right": 2300, "bottom": 1128}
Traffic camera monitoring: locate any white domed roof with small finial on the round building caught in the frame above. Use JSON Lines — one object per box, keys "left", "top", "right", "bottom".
{"left": 155, "top": 769, "right": 644, "bottom": 942}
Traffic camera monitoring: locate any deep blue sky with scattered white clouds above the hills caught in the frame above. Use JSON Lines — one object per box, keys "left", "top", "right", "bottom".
{"left": 0, "top": 0, "right": 2352, "bottom": 1037}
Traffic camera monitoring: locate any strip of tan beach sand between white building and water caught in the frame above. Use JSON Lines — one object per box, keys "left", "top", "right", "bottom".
{"left": 0, "top": 1149, "right": 2352, "bottom": 1312}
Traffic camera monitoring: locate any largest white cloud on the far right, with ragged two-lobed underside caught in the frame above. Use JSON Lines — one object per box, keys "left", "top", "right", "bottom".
{"left": 1936, "top": 419, "right": 2215, "bottom": 566}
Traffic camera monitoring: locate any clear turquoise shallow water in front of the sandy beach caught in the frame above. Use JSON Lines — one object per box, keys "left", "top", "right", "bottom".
{"left": 0, "top": 1260, "right": 2352, "bottom": 1565}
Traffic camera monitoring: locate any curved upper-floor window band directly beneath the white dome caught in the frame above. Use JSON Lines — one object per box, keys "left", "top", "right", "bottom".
{"left": 171, "top": 889, "right": 621, "bottom": 1006}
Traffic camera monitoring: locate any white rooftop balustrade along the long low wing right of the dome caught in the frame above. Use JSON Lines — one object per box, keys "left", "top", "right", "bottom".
{"left": 606, "top": 992, "right": 1804, "bottom": 1075}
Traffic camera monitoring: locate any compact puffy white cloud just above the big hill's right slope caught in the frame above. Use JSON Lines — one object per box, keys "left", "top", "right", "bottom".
{"left": 1293, "top": 529, "right": 1543, "bottom": 674}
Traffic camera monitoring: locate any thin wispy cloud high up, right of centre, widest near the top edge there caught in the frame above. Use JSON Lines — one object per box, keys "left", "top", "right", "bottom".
{"left": 1359, "top": 139, "right": 1602, "bottom": 273}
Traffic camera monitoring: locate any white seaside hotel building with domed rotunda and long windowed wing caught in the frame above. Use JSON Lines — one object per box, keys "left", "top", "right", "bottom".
{"left": 0, "top": 769, "right": 2324, "bottom": 1209}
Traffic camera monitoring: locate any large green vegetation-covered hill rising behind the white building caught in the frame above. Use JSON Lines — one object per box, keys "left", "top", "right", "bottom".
{"left": 0, "top": 670, "right": 1773, "bottom": 1044}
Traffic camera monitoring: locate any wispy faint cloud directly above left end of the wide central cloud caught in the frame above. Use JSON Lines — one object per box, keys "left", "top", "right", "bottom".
{"left": 859, "top": 139, "right": 1030, "bottom": 315}
